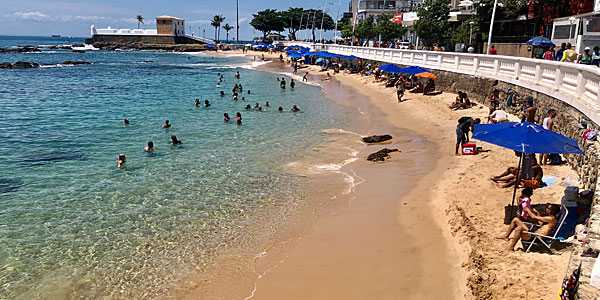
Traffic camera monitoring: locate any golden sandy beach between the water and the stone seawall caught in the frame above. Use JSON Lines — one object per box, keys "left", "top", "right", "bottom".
{"left": 184, "top": 52, "right": 576, "bottom": 299}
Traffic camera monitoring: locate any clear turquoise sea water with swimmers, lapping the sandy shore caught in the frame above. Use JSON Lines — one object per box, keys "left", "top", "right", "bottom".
{"left": 0, "top": 37, "right": 355, "bottom": 299}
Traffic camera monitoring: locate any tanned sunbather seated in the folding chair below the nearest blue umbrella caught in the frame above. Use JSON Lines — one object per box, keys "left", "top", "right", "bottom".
{"left": 498, "top": 204, "right": 560, "bottom": 251}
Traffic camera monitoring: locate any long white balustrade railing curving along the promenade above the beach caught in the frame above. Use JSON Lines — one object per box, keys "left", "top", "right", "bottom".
{"left": 287, "top": 42, "right": 600, "bottom": 125}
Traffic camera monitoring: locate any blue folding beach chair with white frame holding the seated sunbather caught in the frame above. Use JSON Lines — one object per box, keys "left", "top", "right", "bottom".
{"left": 521, "top": 205, "right": 577, "bottom": 254}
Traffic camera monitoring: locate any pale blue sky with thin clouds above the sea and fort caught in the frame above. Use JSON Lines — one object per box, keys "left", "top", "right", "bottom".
{"left": 0, "top": 0, "right": 349, "bottom": 40}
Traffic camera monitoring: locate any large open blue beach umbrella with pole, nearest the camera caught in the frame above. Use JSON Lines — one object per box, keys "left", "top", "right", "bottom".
{"left": 472, "top": 122, "right": 583, "bottom": 211}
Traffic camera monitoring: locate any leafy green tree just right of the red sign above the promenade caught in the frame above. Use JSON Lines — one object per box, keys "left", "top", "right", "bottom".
{"left": 415, "top": 0, "right": 451, "bottom": 45}
